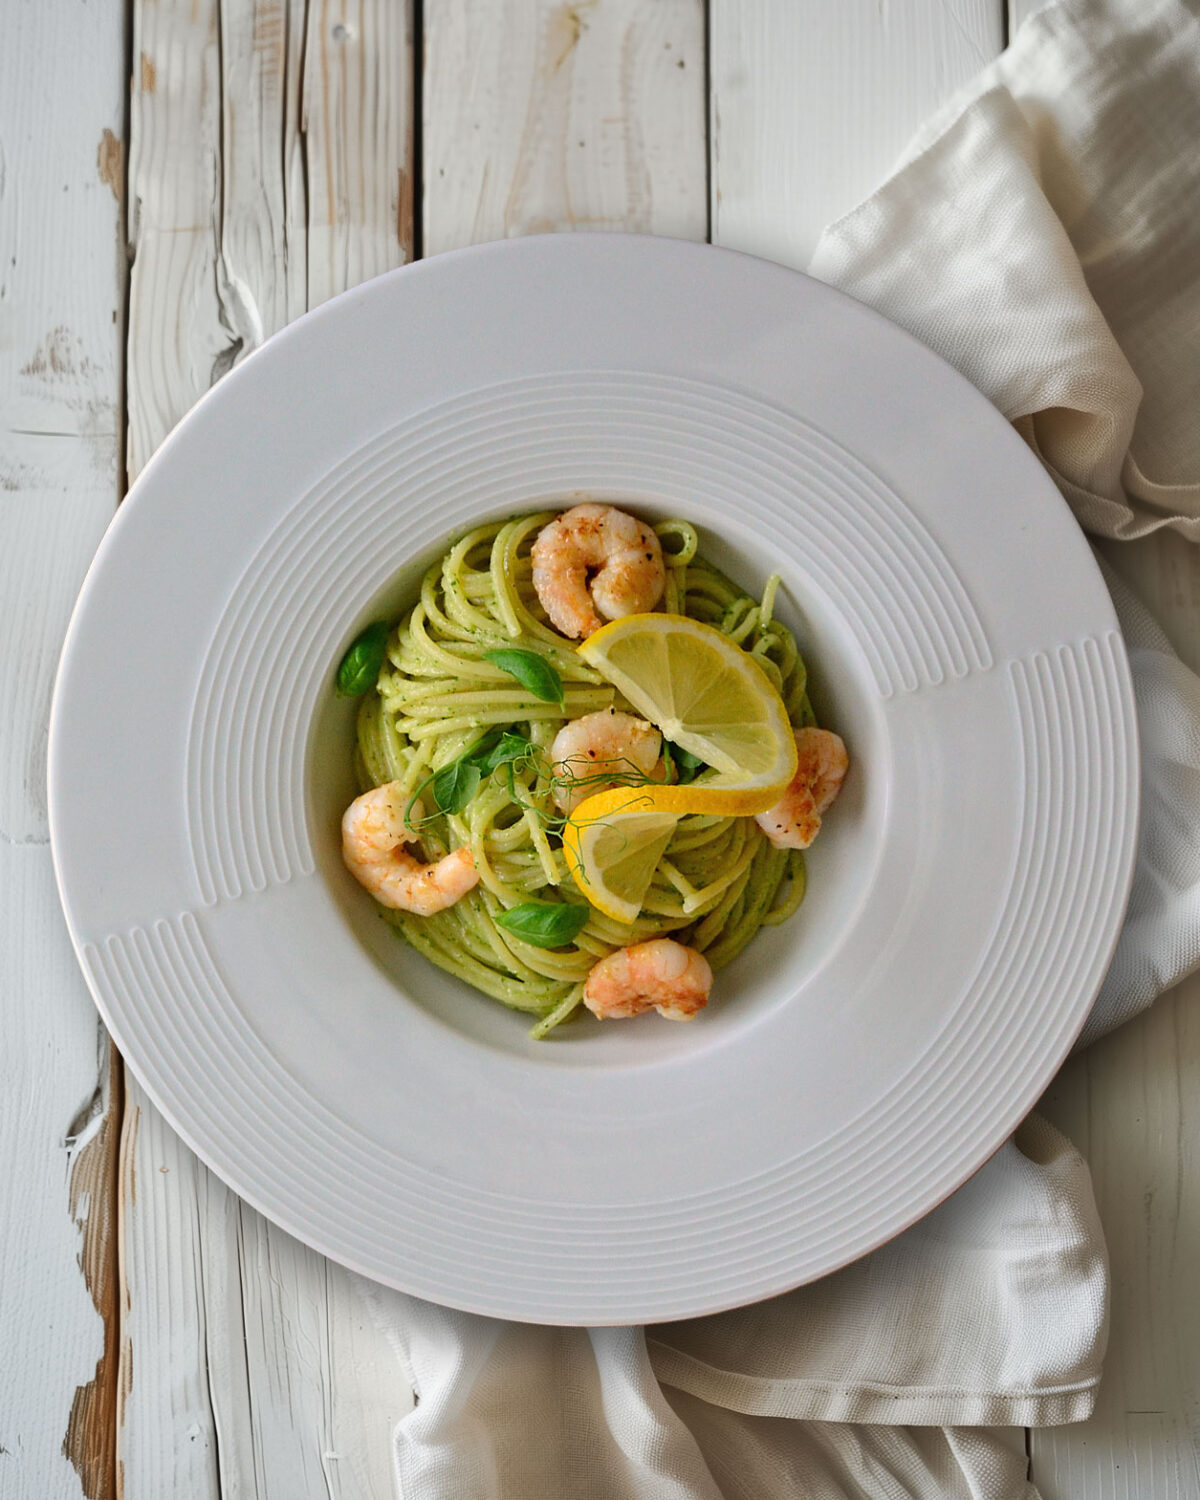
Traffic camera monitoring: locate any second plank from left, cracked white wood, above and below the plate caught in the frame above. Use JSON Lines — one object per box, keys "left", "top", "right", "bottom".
{"left": 119, "top": 0, "right": 413, "bottom": 1500}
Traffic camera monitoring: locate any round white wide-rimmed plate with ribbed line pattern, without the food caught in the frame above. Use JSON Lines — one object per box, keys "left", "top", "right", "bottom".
{"left": 50, "top": 236, "right": 1137, "bottom": 1323}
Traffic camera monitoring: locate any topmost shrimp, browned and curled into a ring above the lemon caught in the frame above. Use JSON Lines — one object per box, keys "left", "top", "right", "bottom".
{"left": 533, "top": 503, "right": 666, "bottom": 641}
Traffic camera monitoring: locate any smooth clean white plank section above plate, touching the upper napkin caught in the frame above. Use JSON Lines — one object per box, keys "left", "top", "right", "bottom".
{"left": 710, "top": 0, "right": 1004, "bottom": 267}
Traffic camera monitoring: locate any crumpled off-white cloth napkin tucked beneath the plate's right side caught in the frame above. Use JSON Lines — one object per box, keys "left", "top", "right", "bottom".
{"left": 360, "top": 0, "right": 1200, "bottom": 1500}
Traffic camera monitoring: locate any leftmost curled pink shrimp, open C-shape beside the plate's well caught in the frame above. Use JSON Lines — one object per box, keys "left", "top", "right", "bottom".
{"left": 342, "top": 782, "right": 479, "bottom": 917}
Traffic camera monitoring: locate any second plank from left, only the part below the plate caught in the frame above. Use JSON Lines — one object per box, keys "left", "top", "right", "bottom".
{"left": 120, "top": 1083, "right": 413, "bottom": 1500}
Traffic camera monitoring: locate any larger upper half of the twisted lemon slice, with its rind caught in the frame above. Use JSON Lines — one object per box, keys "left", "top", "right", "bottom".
{"left": 579, "top": 615, "right": 797, "bottom": 816}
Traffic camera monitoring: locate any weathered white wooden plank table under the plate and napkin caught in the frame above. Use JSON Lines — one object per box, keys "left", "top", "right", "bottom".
{"left": 0, "top": 0, "right": 1200, "bottom": 1500}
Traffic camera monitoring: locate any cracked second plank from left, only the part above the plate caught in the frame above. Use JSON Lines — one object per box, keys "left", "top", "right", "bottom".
{"left": 128, "top": 0, "right": 413, "bottom": 477}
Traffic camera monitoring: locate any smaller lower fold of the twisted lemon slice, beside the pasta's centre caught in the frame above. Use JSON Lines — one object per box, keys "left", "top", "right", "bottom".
{"left": 563, "top": 786, "right": 680, "bottom": 923}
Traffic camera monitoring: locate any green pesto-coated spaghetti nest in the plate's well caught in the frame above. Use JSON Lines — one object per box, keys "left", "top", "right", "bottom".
{"left": 349, "top": 512, "right": 815, "bottom": 1037}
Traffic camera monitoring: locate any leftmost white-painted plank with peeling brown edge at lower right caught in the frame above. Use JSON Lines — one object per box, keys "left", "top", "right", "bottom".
{"left": 0, "top": 0, "right": 125, "bottom": 1500}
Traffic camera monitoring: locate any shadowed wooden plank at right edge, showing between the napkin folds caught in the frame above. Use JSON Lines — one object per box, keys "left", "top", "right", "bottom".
{"left": 1031, "top": 533, "right": 1200, "bottom": 1500}
